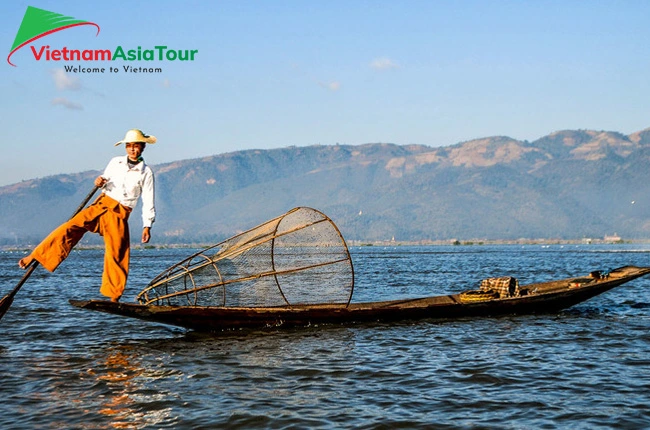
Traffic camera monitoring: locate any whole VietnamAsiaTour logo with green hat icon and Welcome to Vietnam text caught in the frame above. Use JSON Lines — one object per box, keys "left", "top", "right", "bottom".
{"left": 7, "top": 6, "right": 199, "bottom": 73}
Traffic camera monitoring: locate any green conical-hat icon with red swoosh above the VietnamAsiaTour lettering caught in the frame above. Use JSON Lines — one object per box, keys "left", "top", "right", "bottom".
{"left": 7, "top": 6, "right": 99, "bottom": 67}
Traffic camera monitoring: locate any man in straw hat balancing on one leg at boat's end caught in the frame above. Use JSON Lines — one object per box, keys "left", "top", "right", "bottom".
{"left": 18, "top": 129, "right": 156, "bottom": 302}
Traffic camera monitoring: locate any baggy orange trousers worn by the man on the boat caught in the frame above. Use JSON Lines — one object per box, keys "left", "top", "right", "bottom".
{"left": 31, "top": 194, "right": 131, "bottom": 299}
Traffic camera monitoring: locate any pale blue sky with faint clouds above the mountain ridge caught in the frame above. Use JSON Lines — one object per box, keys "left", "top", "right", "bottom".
{"left": 0, "top": 0, "right": 650, "bottom": 186}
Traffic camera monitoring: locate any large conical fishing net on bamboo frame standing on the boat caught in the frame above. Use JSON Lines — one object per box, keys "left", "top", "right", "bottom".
{"left": 138, "top": 207, "right": 354, "bottom": 307}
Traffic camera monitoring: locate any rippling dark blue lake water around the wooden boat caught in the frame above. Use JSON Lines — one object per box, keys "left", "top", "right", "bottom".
{"left": 0, "top": 245, "right": 650, "bottom": 429}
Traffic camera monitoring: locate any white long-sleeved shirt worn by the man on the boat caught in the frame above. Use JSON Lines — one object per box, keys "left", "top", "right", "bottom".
{"left": 102, "top": 155, "right": 156, "bottom": 227}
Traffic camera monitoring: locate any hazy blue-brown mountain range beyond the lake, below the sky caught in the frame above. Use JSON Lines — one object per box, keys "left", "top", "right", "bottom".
{"left": 0, "top": 129, "right": 650, "bottom": 245}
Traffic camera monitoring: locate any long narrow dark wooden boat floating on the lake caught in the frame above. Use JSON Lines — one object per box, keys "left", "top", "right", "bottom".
{"left": 70, "top": 266, "right": 650, "bottom": 331}
